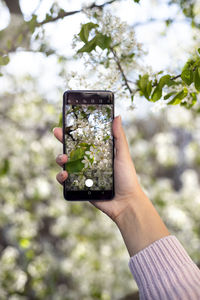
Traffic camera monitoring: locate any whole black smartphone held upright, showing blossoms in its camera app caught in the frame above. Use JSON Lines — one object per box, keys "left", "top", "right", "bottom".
{"left": 63, "top": 90, "right": 114, "bottom": 201}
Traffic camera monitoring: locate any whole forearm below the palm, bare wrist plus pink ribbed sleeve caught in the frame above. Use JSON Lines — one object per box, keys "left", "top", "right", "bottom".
{"left": 115, "top": 195, "right": 200, "bottom": 300}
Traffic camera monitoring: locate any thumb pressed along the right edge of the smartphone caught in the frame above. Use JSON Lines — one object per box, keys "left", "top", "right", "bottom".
{"left": 112, "top": 116, "right": 130, "bottom": 160}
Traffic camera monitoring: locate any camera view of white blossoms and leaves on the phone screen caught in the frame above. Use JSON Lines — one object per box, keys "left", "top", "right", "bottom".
{"left": 65, "top": 104, "right": 113, "bottom": 191}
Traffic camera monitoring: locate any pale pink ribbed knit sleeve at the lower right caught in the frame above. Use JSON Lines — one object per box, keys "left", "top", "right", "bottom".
{"left": 128, "top": 235, "right": 200, "bottom": 300}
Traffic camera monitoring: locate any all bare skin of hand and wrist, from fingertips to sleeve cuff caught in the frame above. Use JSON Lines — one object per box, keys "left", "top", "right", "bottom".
{"left": 53, "top": 116, "right": 169, "bottom": 256}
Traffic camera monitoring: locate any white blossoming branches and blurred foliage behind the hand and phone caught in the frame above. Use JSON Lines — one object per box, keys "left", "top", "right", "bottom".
{"left": 0, "top": 0, "right": 200, "bottom": 300}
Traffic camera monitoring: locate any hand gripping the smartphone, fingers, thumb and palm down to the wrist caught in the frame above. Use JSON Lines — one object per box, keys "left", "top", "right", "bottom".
{"left": 53, "top": 116, "right": 145, "bottom": 221}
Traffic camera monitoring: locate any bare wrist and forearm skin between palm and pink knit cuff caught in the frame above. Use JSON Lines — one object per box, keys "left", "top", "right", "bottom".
{"left": 115, "top": 194, "right": 170, "bottom": 256}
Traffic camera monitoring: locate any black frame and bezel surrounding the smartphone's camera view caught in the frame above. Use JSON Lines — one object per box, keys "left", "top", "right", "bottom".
{"left": 62, "top": 90, "right": 115, "bottom": 201}
